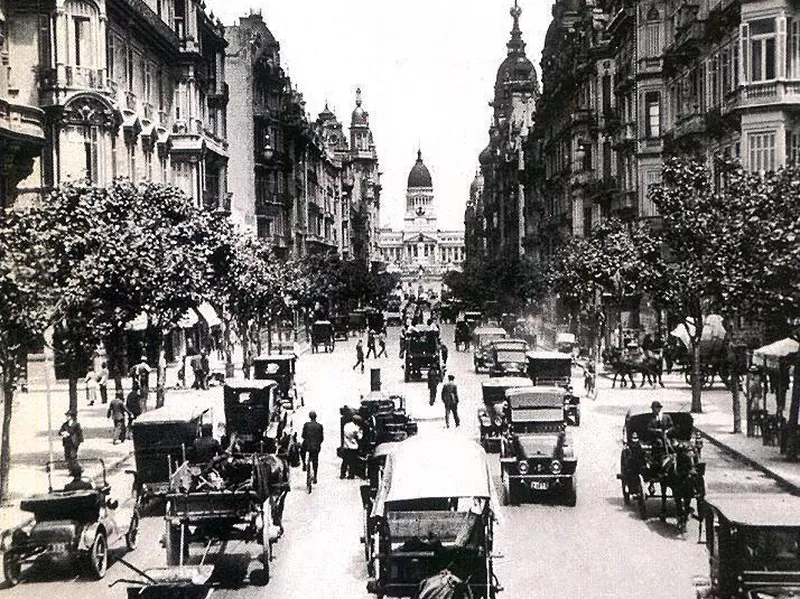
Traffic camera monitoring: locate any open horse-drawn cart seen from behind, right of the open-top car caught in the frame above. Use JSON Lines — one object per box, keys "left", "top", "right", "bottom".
{"left": 164, "top": 453, "right": 278, "bottom": 585}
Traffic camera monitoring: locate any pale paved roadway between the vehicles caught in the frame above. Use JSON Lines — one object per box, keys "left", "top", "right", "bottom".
{"left": 3, "top": 326, "right": 780, "bottom": 599}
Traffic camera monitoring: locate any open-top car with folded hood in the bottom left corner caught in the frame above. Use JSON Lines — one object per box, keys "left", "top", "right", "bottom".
{"left": 0, "top": 459, "right": 139, "bottom": 587}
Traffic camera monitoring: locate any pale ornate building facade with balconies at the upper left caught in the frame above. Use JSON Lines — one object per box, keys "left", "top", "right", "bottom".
{"left": 4, "top": 0, "right": 231, "bottom": 212}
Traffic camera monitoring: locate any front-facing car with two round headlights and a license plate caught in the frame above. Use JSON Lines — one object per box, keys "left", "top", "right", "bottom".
{"left": 500, "top": 386, "right": 578, "bottom": 506}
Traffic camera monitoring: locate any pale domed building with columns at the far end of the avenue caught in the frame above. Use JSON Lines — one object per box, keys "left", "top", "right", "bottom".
{"left": 379, "top": 150, "right": 465, "bottom": 295}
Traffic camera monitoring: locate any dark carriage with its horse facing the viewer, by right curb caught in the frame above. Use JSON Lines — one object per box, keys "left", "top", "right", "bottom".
{"left": 617, "top": 412, "right": 705, "bottom": 530}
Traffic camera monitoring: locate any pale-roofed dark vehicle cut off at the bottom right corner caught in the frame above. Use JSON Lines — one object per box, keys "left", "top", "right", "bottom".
{"left": 695, "top": 493, "right": 800, "bottom": 599}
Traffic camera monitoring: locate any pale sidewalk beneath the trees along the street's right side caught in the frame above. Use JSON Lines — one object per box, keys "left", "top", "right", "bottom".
{"left": 601, "top": 373, "right": 800, "bottom": 495}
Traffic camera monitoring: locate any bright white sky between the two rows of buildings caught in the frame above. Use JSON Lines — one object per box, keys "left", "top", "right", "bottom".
{"left": 206, "top": 0, "right": 553, "bottom": 229}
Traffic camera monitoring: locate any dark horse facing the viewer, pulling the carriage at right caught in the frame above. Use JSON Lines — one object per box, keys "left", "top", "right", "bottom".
{"left": 655, "top": 441, "right": 705, "bottom": 534}
